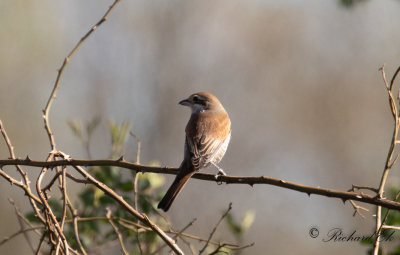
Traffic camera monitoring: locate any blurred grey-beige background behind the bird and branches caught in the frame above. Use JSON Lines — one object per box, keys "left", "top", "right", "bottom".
{"left": 0, "top": 0, "right": 400, "bottom": 254}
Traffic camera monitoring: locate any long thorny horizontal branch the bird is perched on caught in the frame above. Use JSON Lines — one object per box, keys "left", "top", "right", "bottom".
{"left": 0, "top": 159, "right": 400, "bottom": 211}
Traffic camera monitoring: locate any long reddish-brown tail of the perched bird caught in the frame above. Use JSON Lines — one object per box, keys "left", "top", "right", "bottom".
{"left": 157, "top": 169, "right": 195, "bottom": 212}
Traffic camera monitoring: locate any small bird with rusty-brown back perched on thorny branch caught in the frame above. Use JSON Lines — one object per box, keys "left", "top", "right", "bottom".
{"left": 157, "top": 92, "right": 231, "bottom": 212}
